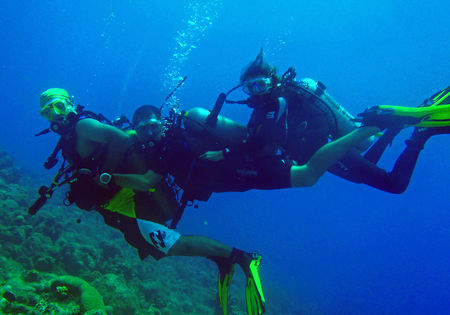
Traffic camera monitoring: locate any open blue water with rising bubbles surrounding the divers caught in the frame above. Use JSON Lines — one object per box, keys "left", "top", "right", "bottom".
{"left": 0, "top": 0, "right": 450, "bottom": 314}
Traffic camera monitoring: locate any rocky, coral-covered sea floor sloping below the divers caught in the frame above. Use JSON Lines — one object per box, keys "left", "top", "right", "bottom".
{"left": 0, "top": 151, "right": 288, "bottom": 315}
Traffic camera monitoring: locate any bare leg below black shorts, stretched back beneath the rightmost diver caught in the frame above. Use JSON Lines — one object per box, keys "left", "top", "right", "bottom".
{"left": 291, "top": 127, "right": 380, "bottom": 187}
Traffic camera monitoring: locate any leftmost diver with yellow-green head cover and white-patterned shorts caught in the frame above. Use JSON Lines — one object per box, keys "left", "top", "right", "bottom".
{"left": 33, "top": 88, "right": 265, "bottom": 314}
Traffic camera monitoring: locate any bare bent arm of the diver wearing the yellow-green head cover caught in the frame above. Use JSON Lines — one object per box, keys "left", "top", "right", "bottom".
{"left": 76, "top": 118, "right": 131, "bottom": 173}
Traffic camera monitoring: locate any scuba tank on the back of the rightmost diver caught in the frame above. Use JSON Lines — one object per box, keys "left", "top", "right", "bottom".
{"left": 290, "top": 78, "right": 375, "bottom": 152}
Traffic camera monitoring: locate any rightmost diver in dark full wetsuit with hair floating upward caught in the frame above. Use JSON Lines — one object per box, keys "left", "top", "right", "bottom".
{"left": 200, "top": 49, "right": 450, "bottom": 194}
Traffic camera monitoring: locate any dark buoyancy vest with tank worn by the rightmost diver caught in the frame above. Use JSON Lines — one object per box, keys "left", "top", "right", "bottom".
{"left": 273, "top": 72, "right": 374, "bottom": 164}
